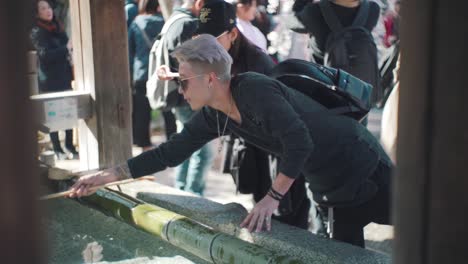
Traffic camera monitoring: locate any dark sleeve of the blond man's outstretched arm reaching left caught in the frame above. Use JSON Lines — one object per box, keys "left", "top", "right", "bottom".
{"left": 127, "top": 109, "right": 218, "bottom": 178}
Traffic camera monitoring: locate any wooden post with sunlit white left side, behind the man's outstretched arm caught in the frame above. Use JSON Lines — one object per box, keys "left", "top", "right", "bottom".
{"left": 70, "top": 0, "right": 132, "bottom": 170}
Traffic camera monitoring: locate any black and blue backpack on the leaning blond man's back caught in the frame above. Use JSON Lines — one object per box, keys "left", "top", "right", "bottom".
{"left": 270, "top": 59, "right": 372, "bottom": 121}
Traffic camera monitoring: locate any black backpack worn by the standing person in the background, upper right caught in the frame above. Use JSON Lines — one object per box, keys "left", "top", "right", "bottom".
{"left": 319, "top": 0, "right": 382, "bottom": 106}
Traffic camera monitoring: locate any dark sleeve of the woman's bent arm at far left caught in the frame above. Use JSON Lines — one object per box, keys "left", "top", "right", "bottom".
{"left": 31, "top": 28, "right": 68, "bottom": 63}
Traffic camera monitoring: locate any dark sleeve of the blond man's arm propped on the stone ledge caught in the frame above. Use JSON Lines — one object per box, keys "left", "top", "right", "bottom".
{"left": 245, "top": 78, "right": 314, "bottom": 178}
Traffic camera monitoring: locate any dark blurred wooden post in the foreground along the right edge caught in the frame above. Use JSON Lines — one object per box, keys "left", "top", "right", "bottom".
{"left": 393, "top": 0, "right": 468, "bottom": 264}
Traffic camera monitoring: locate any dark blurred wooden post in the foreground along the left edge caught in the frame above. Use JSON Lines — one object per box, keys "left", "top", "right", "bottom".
{"left": 0, "top": 1, "right": 47, "bottom": 264}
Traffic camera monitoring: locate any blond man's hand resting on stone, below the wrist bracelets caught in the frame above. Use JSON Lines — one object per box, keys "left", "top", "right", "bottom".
{"left": 240, "top": 195, "right": 279, "bottom": 232}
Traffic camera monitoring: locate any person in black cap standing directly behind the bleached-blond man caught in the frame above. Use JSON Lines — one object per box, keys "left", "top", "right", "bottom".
{"left": 197, "top": 1, "right": 310, "bottom": 229}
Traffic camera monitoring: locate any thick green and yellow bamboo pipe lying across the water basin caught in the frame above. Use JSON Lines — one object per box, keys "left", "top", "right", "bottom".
{"left": 77, "top": 189, "right": 304, "bottom": 264}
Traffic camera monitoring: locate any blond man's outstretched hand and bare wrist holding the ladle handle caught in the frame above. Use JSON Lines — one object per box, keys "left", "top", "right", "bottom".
{"left": 69, "top": 166, "right": 129, "bottom": 198}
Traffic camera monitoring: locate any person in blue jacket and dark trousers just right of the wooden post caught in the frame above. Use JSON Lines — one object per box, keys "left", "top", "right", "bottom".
{"left": 128, "top": 0, "right": 164, "bottom": 151}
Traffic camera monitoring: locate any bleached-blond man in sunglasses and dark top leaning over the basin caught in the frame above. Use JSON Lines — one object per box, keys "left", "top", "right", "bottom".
{"left": 71, "top": 34, "right": 392, "bottom": 247}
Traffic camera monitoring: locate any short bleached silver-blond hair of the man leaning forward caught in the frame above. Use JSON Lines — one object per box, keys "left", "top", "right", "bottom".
{"left": 171, "top": 34, "right": 232, "bottom": 81}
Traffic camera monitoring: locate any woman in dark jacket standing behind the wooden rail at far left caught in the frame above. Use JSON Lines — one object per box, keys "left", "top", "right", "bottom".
{"left": 31, "top": 0, "right": 78, "bottom": 159}
